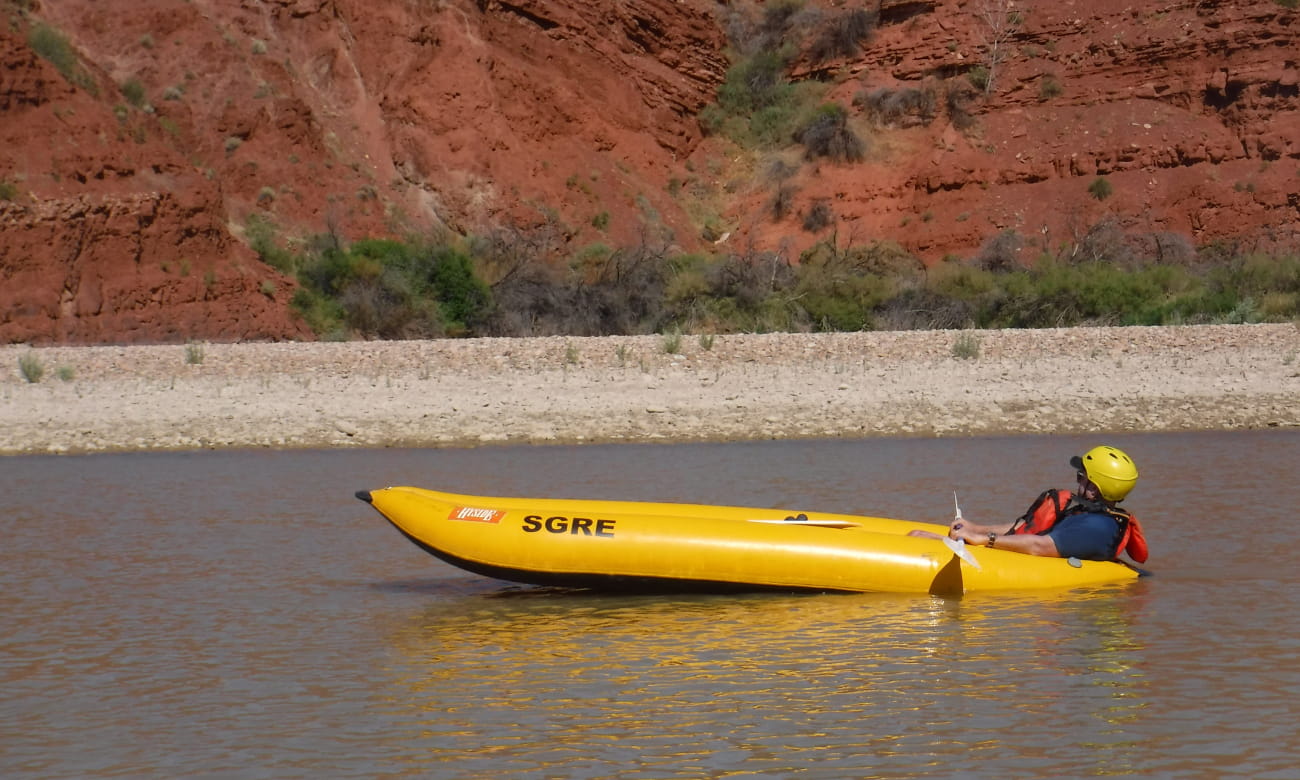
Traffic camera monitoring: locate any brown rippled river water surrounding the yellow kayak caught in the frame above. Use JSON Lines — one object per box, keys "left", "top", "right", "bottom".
{"left": 0, "top": 430, "right": 1300, "bottom": 779}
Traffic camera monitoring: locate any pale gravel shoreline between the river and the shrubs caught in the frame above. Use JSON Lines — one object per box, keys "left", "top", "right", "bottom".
{"left": 0, "top": 324, "right": 1300, "bottom": 454}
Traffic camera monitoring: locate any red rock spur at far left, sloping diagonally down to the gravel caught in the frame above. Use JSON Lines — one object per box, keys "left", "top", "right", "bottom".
{"left": 0, "top": 21, "right": 308, "bottom": 343}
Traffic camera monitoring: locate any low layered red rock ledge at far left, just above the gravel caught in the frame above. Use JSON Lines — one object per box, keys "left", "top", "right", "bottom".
{"left": 0, "top": 191, "right": 308, "bottom": 343}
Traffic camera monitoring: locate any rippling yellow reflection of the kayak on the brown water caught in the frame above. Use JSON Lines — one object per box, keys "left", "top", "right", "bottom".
{"left": 374, "top": 588, "right": 1144, "bottom": 776}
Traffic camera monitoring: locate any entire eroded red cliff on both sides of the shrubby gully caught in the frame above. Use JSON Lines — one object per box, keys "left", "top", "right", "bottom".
{"left": 0, "top": 0, "right": 1300, "bottom": 343}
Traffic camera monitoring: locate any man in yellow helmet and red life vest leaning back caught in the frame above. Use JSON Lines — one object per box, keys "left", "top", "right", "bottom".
{"left": 914, "top": 445, "right": 1148, "bottom": 563}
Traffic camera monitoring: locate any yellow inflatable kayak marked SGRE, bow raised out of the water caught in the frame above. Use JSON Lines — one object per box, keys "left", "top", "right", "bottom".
{"left": 356, "top": 488, "right": 1138, "bottom": 594}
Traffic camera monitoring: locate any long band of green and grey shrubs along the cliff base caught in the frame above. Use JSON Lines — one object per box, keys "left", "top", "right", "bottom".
{"left": 228, "top": 206, "right": 1300, "bottom": 340}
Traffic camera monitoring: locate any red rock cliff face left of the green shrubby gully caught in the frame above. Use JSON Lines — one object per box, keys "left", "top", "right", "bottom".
{"left": 0, "top": 0, "right": 725, "bottom": 343}
